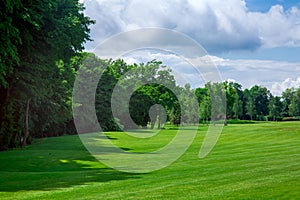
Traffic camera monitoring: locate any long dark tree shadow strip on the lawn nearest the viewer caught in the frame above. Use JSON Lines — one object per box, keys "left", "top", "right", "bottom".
{"left": 0, "top": 168, "right": 138, "bottom": 192}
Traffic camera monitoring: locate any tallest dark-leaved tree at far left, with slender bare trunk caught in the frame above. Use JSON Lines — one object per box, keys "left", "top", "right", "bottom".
{"left": 0, "top": 0, "right": 93, "bottom": 149}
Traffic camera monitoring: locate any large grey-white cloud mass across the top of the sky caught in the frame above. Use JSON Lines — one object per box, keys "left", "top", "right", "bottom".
{"left": 85, "top": 0, "right": 300, "bottom": 52}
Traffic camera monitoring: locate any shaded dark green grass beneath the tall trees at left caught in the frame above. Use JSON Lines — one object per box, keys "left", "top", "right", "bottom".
{"left": 0, "top": 136, "right": 139, "bottom": 192}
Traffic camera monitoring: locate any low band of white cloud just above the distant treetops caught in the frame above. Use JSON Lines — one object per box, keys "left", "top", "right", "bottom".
{"left": 124, "top": 51, "right": 300, "bottom": 95}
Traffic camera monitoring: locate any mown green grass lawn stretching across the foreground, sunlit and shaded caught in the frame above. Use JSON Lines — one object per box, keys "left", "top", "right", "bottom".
{"left": 0, "top": 122, "right": 300, "bottom": 199}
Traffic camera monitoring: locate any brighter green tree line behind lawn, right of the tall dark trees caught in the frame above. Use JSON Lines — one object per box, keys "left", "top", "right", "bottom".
{"left": 75, "top": 54, "right": 300, "bottom": 131}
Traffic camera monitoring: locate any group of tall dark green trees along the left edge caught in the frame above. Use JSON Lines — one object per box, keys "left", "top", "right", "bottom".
{"left": 0, "top": 0, "right": 94, "bottom": 150}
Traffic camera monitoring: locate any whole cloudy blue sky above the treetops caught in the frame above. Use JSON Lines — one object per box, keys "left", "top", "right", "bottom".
{"left": 82, "top": 0, "right": 300, "bottom": 95}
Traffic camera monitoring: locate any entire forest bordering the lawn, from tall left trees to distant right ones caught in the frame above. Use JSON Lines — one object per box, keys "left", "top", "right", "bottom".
{"left": 0, "top": 0, "right": 300, "bottom": 150}
